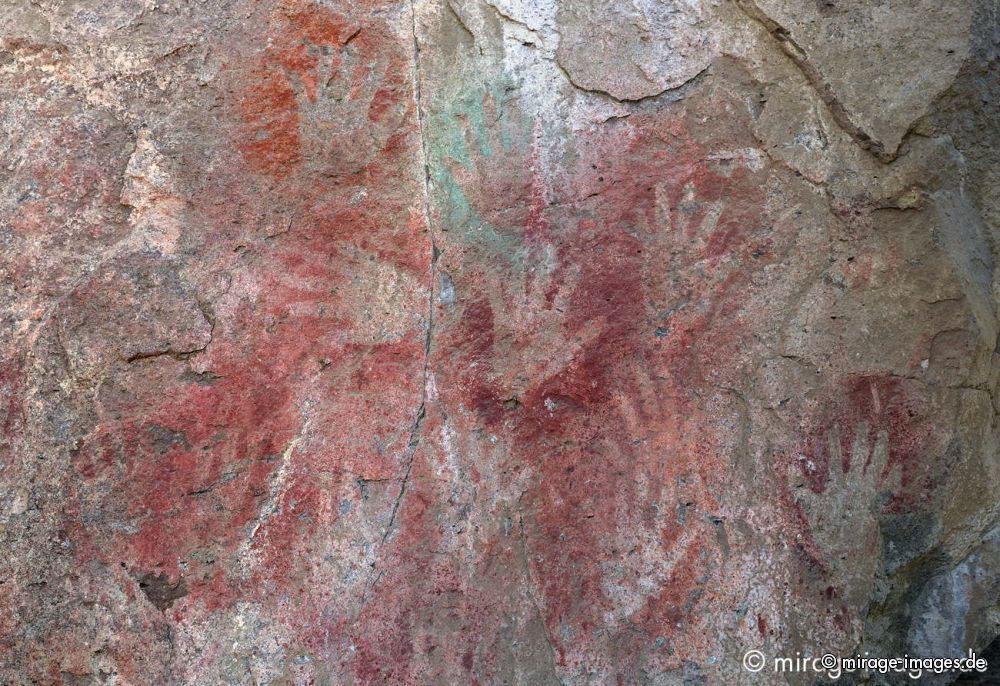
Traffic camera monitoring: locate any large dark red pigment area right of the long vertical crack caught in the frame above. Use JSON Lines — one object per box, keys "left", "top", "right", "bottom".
{"left": 430, "top": 95, "right": 777, "bottom": 678}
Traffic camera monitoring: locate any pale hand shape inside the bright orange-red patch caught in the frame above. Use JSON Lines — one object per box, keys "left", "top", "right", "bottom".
{"left": 284, "top": 37, "right": 406, "bottom": 177}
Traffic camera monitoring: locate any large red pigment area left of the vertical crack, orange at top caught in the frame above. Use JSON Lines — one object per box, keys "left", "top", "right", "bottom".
{"left": 60, "top": 9, "right": 430, "bottom": 628}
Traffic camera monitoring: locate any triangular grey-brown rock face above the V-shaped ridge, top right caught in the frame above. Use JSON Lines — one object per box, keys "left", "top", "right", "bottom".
{"left": 739, "top": 0, "right": 972, "bottom": 157}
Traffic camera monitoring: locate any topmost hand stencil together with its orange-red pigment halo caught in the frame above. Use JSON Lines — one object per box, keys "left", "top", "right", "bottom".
{"left": 239, "top": 9, "right": 413, "bottom": 178}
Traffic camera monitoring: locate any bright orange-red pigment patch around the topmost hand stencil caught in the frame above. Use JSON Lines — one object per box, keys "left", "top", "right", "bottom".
{"left": 237, "top": 0, "right": 412, "bottom": 181}
